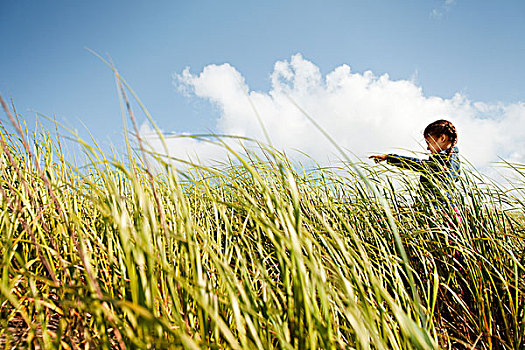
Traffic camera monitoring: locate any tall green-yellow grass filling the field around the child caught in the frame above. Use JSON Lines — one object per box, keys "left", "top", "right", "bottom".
{"left": 0, "top": 95, "right": 525, "bottom": 349}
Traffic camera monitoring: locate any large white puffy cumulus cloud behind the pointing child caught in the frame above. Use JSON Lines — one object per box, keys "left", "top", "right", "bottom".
{"left": 143, "top": 54, "right": 525, "bottom": 178}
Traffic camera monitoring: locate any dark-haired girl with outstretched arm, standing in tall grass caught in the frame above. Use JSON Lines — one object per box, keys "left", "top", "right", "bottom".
{"left": 370, "top": 119, "right": 460, "bottom": 207}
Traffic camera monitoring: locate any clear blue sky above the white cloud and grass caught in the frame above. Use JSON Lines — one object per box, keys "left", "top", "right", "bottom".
{"left": 0, "top": 0, "right": 525, "bottom": 169}
